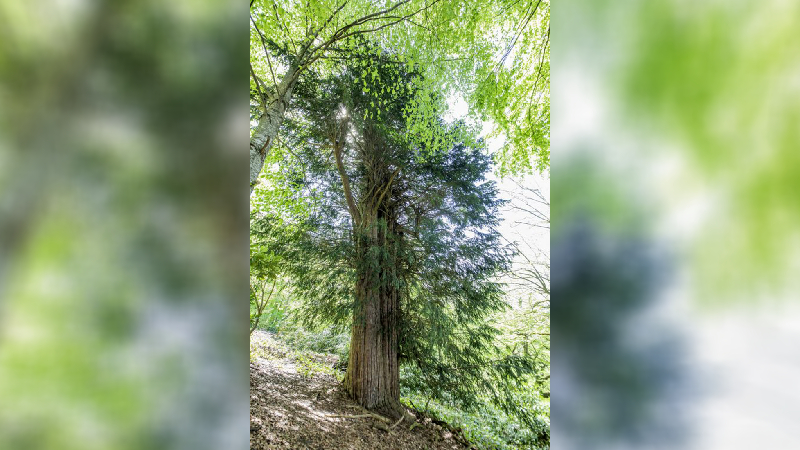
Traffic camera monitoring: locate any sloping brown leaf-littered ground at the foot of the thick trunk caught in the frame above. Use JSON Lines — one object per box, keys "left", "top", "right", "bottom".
{"left": 250, "top": 330, "right": 469, "bottom": 450}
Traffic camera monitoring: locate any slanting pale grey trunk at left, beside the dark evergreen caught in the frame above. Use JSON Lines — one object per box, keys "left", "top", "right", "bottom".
{"left": 250, "top": 66, "right": 297, "bottom": 194}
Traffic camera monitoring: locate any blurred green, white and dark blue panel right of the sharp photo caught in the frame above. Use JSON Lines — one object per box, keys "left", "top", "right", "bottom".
{"left": 551, "top": 0, "right": 800, "bottom": 449}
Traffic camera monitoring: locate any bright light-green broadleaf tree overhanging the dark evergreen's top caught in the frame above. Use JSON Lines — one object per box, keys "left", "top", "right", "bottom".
{"left": 250, "top": 0, "right": 549, "bottom": 192}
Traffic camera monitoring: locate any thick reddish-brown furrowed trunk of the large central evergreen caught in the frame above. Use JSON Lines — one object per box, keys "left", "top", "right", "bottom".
{"left": 336, "top": 126, "right": 403, "bottom": 418}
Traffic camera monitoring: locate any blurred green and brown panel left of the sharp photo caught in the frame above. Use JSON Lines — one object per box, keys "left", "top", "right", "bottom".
{"left": 0, "top": 0, "right": 249, "bottom": 450}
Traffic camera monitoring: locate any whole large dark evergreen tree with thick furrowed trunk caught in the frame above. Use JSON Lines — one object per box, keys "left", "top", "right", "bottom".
{"left": 253, "top": 56, "right": 525, "bottom": 416}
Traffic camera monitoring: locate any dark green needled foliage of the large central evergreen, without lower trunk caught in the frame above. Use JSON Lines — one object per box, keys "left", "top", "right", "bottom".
{"left": 248, "top": 48, "right": 545, "bottom": 429}
